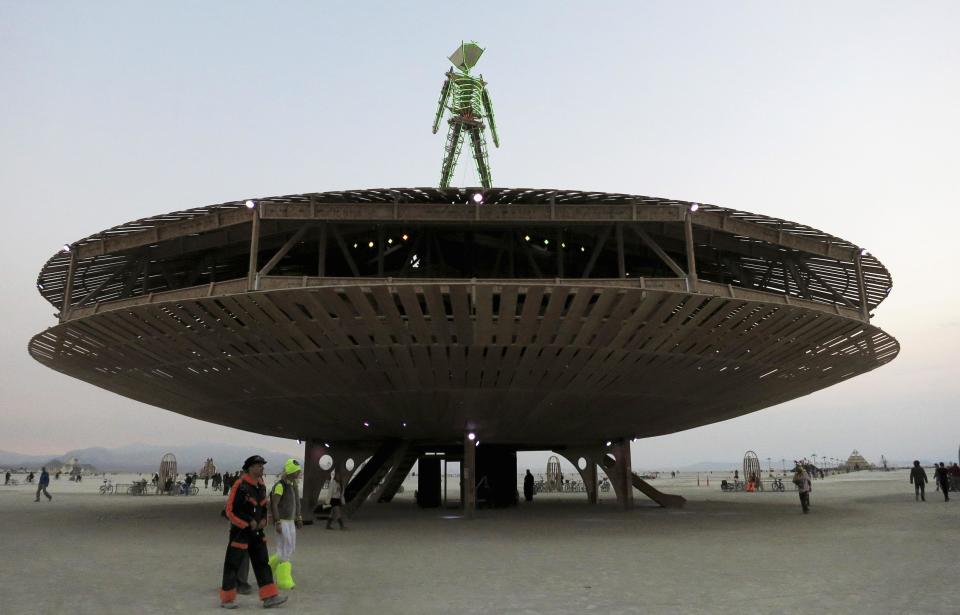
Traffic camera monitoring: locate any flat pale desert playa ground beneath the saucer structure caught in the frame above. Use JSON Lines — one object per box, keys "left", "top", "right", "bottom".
{"left": 0, "top": 471, "right": 960, "bottom": 615}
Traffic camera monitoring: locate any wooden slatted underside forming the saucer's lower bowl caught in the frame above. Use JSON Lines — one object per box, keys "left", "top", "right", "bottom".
{"left": 31, "top": 284, "right": 897, "bottom": 448}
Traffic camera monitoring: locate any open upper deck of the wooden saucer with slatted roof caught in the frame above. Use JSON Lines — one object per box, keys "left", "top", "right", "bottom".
{"left": 37, "top": 188, "right": 891, "bottom": 320}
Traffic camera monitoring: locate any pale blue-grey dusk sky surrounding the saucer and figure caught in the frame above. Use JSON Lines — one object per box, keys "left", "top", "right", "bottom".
{"left": 0, "top": 0, "right": 960, "bottom": 468}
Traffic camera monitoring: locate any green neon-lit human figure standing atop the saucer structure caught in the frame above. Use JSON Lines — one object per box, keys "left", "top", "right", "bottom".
{"left": 433, "top": 41, "right": 500, "bottom": 188}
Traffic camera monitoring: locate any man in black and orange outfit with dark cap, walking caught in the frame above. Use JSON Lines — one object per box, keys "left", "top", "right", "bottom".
{"left": 220, "top": 455, "right": 287, "bottom": 609}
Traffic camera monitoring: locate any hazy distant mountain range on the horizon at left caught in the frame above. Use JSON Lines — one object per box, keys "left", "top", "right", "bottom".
{"left": 0, "top": 444, "right": 289, "bottom": 473}
